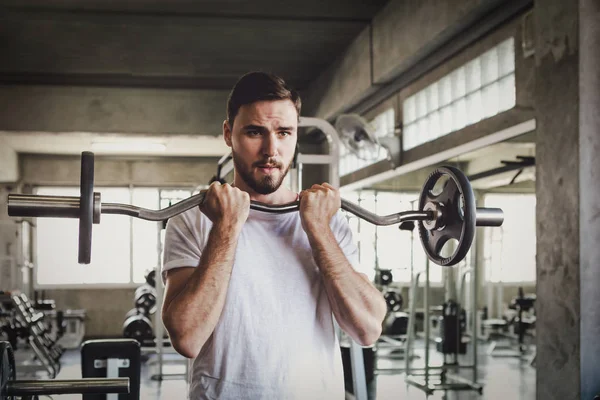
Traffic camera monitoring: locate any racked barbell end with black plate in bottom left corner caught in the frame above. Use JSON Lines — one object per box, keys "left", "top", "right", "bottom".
{"left": 0, "top": 342, "right": 129, "bottom": 400}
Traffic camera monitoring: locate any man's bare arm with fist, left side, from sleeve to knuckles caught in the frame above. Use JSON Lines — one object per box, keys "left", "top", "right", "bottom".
{"left": 162, "top": 182, "right": 250, "bottom": 358}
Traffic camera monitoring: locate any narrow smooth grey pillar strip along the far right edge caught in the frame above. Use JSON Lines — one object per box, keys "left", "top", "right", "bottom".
{"left": 579, "top": 0, "right": 600, "bottom": 400}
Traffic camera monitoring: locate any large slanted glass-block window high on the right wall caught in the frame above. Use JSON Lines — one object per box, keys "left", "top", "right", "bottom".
{"left": 402, "top": 38, "right": 516, "bottom": 150}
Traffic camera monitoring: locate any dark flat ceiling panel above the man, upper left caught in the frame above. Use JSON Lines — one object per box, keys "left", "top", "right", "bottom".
{"left": 0, "top": 0, "right": 387, "bottom": 90}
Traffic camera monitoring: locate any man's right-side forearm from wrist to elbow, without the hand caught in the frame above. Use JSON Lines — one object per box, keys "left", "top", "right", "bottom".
{"left": 307, "top": 223, "right": 386, "bottom": 345}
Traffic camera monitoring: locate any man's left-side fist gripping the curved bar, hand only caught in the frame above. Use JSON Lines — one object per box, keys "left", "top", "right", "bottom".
{"left": 200, "top": 182, "right": 250, "bottom": 230}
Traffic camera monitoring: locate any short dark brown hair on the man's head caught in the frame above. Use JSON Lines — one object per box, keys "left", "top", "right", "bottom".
{"left": 227, "top": 71, "right": 302, "bottom": 128}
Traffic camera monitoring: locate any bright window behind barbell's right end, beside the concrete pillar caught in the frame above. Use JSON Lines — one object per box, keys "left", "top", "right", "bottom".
{"left": 484, "top": 194, "right": 536, "bottom": 283}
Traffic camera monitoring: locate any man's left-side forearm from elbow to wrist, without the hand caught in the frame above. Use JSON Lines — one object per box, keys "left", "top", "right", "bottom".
{"left": 163, "top": 225, "right": 239, "bottom": 351}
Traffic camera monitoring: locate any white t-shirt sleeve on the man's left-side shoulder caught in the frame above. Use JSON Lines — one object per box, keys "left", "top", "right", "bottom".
{"left": 162, "top": 211, "right": 209, "bottom": 280}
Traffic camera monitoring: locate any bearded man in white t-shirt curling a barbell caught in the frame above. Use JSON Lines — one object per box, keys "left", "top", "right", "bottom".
{"left": 163, "top": 72, "right": 386, "bottom": 399}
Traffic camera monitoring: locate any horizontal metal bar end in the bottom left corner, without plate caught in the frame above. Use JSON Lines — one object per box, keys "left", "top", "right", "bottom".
{"left": 4, "top": 378, "right": 129, "bottom": 397}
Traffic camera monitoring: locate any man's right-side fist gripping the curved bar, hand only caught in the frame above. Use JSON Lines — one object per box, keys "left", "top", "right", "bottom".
{"left": 299, "top": 183, "right": 342, "bottom": 233}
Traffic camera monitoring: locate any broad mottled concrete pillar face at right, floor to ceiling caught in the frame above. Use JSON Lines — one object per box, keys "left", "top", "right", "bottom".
{"left": 534, "top": 0, "right": 580, "bottom": 400}
